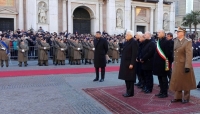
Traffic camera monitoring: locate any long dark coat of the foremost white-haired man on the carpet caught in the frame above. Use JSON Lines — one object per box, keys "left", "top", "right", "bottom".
{"left": 118, "top": 38, "right": 138, "bottom": 82}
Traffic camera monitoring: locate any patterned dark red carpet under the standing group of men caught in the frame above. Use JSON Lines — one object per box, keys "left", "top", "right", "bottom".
{"left": 84, "top": 85, "right": 200, "bottom": 114}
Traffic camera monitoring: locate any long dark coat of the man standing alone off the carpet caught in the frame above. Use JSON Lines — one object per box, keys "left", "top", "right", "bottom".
{"left": 94, "top": 38, "right": 108, "bottom": 68}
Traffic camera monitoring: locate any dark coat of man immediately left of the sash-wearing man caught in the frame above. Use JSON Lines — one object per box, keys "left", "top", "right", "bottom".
{"left": 141, "top": 40, "right": 156, "bottom": 70}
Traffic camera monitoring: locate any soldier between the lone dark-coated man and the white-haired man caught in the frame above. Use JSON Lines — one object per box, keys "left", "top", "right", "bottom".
{"left": 111, "top": 40, "right": 119, "bottom": 63}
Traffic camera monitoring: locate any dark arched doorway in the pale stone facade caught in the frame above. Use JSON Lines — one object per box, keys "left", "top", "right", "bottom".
{"left": 73, "top": 7, "right": 91, "bottom": 34}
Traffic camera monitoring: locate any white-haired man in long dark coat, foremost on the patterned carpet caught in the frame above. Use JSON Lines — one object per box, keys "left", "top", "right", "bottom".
{"left": 118, "top": 30, "right": 139, "bottom": 97}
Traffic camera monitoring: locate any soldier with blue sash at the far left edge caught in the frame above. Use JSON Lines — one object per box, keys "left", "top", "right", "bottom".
{"left": 0, "top": 34, "right": 10, "bottom": 67}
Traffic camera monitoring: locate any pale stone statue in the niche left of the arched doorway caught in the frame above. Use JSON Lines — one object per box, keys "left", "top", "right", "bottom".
{"left": 38, "top": 2, "right": 48, "bottom": 23}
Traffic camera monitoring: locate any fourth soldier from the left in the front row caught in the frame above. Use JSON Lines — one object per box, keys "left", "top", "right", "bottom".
{"left": 56, "top": 39, "right": 67, "bottom": 65}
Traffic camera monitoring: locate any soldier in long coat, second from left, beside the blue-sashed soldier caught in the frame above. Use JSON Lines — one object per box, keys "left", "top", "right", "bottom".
{"left": 18, "top": 40, "right": 29, "bottom": 67}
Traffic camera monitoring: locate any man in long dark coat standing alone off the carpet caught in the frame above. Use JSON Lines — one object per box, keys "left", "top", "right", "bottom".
{"left": 93, "top": 31, "right": 108, "bottom": 82}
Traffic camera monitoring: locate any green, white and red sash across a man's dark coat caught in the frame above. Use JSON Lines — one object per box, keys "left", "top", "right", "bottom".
{"left": 156, "top": 40, "right": 169, "bottom": 71}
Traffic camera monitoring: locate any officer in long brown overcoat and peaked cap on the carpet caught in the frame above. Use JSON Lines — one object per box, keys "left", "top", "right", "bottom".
{"left": 169, "top": 27, "right": 196, "bottom": 103}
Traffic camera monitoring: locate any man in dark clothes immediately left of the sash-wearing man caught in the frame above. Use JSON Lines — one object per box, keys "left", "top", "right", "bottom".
{"left": 140, "top": 32, "right": 156, "bottom": 93}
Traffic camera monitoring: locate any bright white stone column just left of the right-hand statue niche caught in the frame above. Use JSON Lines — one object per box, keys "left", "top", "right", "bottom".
{"left": 106, "top": 0, "right": 116, "bottom": 35}
